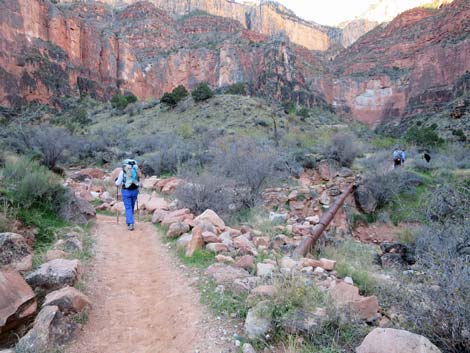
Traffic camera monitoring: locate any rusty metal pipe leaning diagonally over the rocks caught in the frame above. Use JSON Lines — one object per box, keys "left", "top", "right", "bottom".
{"left": 292, "top": 184, "right": 356, "bottom": 258}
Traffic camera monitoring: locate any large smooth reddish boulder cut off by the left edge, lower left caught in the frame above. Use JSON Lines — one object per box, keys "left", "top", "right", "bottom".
{"left": 0, "top": 271, "right": 37, "bottom": 336}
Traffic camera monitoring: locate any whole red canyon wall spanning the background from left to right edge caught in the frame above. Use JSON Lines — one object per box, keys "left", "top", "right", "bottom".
{"left": 0, "top": 0, "right": 470, "bottom": 125}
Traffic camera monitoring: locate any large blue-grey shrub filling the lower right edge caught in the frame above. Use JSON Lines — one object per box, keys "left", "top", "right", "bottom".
{"left": 402, "top": 220, "right": 470, "bottom": 353}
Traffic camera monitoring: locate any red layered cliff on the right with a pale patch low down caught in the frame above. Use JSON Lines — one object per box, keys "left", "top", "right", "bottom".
{"left": 327, "top": 0, "right": 470, "bottom": 125}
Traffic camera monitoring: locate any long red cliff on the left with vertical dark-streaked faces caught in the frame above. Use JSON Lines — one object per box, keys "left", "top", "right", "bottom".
{"left": 0, "top": 0, "right": 330, "bottom": 106}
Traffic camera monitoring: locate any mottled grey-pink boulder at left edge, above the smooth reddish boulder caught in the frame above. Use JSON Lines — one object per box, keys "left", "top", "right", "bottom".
{"left": 0, "top": 233, "right": 33, "bottom": 271}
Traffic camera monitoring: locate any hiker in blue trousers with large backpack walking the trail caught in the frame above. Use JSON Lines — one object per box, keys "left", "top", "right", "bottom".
{"left": 114, "top": 159, "right": 141, "bottom": 230}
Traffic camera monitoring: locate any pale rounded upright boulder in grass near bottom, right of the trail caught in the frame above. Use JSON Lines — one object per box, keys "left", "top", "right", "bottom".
{"left": 245, "top": 300, "right": 273, "bottom": 339}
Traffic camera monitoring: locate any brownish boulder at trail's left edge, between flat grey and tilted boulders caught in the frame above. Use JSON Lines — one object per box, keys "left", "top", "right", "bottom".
{"left": 43, "top": 286, "right": 91, "bottom": 314}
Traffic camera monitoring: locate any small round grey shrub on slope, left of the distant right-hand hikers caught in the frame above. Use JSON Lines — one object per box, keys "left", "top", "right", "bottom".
{"left": 322, "top": 133, "right": 361, "bottom": 167}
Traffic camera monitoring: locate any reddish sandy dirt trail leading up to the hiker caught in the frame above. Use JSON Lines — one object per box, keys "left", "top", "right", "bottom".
{"left": 67, "top": 216, "right": 231, "bottom": 353}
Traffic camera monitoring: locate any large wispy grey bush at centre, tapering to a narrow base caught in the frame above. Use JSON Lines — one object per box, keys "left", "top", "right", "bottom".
{"left": 212, "top": 138, "right": 279, "bottom": 208}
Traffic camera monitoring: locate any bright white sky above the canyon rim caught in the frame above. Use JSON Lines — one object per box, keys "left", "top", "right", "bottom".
{"left": 276, "top": 0, "right": 376, "bottom": 26}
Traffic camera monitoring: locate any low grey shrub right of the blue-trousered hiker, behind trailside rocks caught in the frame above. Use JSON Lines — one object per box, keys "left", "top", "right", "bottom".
{"left": 175, "top": 173, "right": 233, "bottom": 215}
